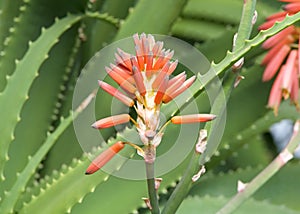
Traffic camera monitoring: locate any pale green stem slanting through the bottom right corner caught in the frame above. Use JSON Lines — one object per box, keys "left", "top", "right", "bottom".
{"left": 218, "top": 120, "right": 300, "bottom": 214}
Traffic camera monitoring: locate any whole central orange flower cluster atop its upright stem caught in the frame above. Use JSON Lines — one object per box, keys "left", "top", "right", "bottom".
{"left": 86, "top": 34, "right": 215, "bottom": 174}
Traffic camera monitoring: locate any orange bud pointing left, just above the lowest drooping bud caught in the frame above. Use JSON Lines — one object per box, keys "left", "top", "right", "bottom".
{"left": 92, "top": 114, "right": 130, "bottom": 129}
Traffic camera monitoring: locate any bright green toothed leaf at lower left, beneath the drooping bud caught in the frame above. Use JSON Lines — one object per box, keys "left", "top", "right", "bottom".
{"left": 20, "top": 126, "right": 135, "bottom": 213}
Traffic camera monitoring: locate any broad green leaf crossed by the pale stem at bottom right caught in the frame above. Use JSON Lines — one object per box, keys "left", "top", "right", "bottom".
{"left": 190, "top": 161, "right": 300, "bottom": 212}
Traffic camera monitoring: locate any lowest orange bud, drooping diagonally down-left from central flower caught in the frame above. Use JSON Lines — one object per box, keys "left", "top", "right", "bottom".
{"left": 85, "top": 141, "right": 124, "bottom": 175}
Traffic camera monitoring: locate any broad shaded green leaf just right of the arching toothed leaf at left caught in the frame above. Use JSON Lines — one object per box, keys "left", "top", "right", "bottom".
{"left": 0, "top": 27, "right": 81, "bottom": 198}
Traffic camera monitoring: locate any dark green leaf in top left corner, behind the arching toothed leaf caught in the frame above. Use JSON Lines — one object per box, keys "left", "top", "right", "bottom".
{"left": 0, "top": 0, "right": 84, "bottom": 91}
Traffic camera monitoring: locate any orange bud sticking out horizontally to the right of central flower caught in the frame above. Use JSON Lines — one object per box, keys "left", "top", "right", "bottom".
{"left": 171, "top": 114, "right": 216, "bottom": 124}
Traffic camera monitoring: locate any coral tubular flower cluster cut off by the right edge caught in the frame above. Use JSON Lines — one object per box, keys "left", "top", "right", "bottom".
{"left": 259, "top": 0, "right": 300, "bottom": 114}
